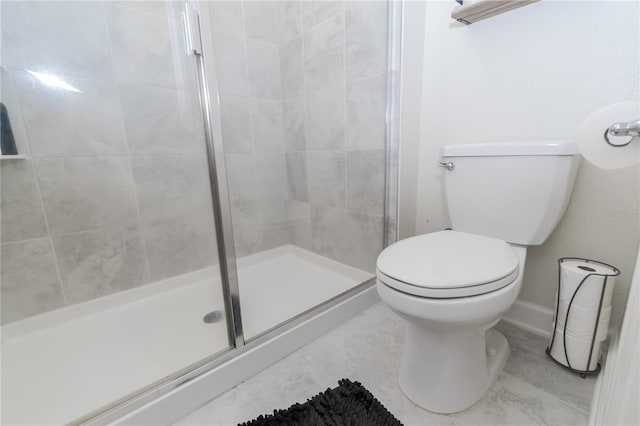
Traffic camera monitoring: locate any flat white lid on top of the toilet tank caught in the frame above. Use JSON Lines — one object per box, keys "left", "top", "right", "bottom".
{"left": 442, "top": 140, "right": 579, "bottom": 157}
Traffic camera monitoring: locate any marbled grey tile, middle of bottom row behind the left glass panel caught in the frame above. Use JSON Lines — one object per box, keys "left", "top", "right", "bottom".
{"left": 54, "top": 227, "right": 148, "bottom": 303}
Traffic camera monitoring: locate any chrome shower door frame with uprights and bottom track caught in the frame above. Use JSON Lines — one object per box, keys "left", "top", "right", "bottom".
{"left": 72, "top": 0, "right": 403, "bottom": 424}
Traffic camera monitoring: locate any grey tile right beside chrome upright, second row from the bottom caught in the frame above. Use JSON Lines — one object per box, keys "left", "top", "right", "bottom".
{"left": 225, "top": 154, "right": 258, "bottom": 208}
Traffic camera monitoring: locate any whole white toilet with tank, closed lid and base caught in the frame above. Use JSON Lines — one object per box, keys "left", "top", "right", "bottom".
{"left": 376, "top": 141, "right": 580, "bottom": 413}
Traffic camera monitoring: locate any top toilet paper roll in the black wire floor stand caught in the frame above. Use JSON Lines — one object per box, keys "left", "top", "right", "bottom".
{"left": 559, "top": 260, "right": 617, "bottom": 308}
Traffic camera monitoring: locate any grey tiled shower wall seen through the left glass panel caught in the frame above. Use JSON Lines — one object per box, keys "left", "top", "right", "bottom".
{"left": 0, "top": 1, "right": 217, "bottom": 323}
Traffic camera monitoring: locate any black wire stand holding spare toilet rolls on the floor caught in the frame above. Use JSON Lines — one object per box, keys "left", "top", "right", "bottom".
{"left": 545, "top": 257, "right": 620, "bottom": 378}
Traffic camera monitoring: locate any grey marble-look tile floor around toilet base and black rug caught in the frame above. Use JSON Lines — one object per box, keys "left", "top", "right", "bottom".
{"left": 176, "top": 303, "right": 595, "bottom": 426}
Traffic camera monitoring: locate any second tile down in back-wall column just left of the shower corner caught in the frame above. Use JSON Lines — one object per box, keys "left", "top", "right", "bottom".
{"left": 251, "top": 99, "right": 284, "bottom": 152}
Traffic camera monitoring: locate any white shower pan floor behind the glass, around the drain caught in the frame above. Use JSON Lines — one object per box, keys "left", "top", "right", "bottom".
{"left": 2, "top": 245, "right": 372, "bottom": 424}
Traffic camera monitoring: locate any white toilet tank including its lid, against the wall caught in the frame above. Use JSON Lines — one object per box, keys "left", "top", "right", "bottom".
{"left": 442, "top": 141, "right": 580, "bottom": 245}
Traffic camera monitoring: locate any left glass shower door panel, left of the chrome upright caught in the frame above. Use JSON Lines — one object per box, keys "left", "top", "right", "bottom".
{"left": 0, "top": 1, "right": 230, "bottom": 424}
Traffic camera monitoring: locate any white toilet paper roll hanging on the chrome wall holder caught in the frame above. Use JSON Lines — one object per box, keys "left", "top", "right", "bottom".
{"left": 576, "top": 101, "right": 640, "bottom": 169}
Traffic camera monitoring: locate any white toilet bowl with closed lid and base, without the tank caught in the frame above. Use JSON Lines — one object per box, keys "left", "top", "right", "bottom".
{"left": 376, "top": 231, "right": 526, "bottom": 413}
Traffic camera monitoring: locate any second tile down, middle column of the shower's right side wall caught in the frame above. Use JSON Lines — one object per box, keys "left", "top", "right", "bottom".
{"left": 303, "top": 13, "right": 344, "bottom": 92}
